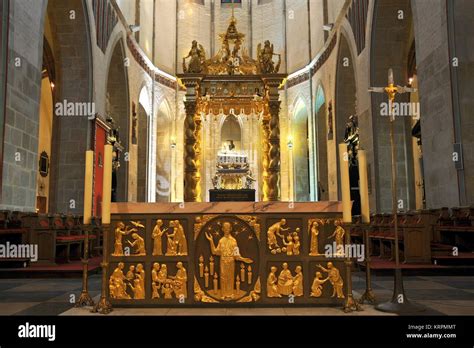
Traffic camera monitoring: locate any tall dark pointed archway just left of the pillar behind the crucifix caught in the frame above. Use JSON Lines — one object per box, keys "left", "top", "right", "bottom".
{"left": 335, "top": 33, "right": 360, "bottom": 215}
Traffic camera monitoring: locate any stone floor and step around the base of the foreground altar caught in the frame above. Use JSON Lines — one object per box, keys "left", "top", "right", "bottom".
{"left": 0, "top": 273, "right": 474, "bottom": 315}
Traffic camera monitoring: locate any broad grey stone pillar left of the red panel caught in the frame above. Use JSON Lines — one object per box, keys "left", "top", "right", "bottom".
{"left": 43, "top": 0, "right": 95, "bottom": 213}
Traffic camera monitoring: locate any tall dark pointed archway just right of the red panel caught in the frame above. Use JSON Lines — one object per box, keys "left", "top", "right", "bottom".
{"left": 105, "top": 37, "right": 130, "bottom": 202}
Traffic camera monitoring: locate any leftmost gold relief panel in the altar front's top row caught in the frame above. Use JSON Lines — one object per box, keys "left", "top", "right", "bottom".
{"left": 111, "top": 221, "right": 146, "bottom": 256}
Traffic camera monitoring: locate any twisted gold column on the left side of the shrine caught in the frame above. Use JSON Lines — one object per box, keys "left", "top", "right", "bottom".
{"left": 182, "top": 75, "right": 201, "bottom": 202}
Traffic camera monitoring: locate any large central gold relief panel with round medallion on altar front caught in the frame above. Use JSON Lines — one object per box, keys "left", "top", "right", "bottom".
{"left": 194, "top": 215, "right": 260, "bottom": 302}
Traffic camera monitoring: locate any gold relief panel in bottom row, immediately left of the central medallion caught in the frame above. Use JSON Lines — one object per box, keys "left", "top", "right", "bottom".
{"left": 150, "top": 262, "right": 188, "bottom": 303}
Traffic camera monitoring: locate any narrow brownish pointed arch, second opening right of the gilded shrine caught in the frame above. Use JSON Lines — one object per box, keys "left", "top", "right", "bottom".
{"left": 314, "top": 85, "right": 329, "bottom": 201}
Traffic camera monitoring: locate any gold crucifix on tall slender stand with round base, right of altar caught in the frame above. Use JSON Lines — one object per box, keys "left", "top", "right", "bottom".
{"left": 369, "top": 68, "right": 424, "bottom": 314}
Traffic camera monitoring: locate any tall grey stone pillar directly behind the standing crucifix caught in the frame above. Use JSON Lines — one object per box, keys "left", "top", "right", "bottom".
{"left": 370, "top": 0, "right": 415, "bottom": 212}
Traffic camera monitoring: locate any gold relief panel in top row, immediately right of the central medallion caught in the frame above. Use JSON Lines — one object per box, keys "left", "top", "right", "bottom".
{"left": 266, "top": 218, "right": 303, "bottom": 256}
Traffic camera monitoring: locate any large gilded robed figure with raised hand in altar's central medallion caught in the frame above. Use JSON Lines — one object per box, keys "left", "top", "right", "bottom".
{"left": 205, "top": 221, "right": 253, "bottom": 300}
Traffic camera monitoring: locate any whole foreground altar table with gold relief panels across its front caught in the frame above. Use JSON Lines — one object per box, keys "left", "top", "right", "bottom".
{"left": 107, "top": 202, "right": 352, "bottom": 307}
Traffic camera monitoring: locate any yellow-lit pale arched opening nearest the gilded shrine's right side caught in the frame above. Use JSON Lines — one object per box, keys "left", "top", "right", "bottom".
{"left": 290, "top": 100, "right": 311, "bottom": 202}
